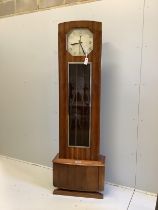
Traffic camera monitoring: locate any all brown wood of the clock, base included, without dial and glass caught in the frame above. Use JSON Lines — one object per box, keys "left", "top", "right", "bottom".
{"left": 53, "top": 21, "right": 105, "bottom": 198}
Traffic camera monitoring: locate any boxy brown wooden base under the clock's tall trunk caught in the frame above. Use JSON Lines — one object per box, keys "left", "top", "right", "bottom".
{"left": 53, "top": 155, "right": 105, "bottom": 198}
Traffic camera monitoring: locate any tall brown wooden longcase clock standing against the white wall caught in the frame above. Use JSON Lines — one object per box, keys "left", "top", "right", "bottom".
{"left": 53, "top": 21, "right": 105, "bottom": 198}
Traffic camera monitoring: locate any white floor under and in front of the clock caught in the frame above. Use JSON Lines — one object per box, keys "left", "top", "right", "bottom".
{"left": 0, "top": 156, "right": 158, "bottom": 210}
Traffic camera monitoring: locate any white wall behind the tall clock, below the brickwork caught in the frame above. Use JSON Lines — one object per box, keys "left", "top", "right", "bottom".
{"left": 0, "top": 0, "right": 158, "bottom": 192}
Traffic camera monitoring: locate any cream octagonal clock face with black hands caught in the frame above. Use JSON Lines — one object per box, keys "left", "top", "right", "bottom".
{"left": 67, "top": 28, "right": 93, "bottom": 56}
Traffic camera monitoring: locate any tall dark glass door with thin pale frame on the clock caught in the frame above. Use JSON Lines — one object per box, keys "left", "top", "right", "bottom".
{"left": 68, "top": 62, "right": 91, "bottom": 148}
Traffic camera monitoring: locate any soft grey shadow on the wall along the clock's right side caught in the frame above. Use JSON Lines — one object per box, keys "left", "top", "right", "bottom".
{"left": 100, "top": 43, "right": 119, "bottom": 177}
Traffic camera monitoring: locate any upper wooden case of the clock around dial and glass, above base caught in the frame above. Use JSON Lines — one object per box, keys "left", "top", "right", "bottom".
{"left": 58, "top": 21, "right": 102, "bottom": 160}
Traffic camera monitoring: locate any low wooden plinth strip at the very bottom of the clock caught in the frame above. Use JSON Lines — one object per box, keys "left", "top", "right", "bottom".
{"left": 53, "top": 189, "right": 103, "bottom": 199}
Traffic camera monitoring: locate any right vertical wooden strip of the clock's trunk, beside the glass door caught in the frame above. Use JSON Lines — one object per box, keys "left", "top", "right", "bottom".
{"left": 91, "top": 22, "right": 102, "bottom": 160}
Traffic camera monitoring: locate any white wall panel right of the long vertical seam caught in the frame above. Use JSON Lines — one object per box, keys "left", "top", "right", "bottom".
{"left": 137, "top": 0, "right": 158, "bottom": 192}
